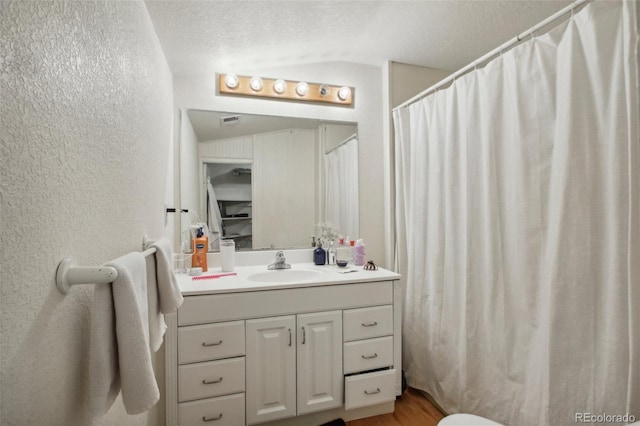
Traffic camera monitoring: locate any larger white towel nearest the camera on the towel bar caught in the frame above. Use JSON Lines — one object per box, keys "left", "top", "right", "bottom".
{"left": 89, "top": 252, "right": 160, "bottom": 415}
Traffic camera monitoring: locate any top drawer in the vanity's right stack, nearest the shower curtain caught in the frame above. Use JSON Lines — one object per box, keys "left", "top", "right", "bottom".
{"left": 343, "top": 305, "right": 393, "bottom": 342}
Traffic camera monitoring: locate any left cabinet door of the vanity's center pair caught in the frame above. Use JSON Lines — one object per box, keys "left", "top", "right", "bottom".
{"left": 246, "top": 315, "right": 296, "bottom": 424}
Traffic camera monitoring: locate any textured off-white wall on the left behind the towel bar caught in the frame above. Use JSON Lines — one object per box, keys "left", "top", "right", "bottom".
{"left": 0, "top": 0, "right": 173, "bottom": 425}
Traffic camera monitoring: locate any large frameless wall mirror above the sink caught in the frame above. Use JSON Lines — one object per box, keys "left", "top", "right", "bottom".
{"left": 180, "top": 109, "right": 359, "bottom": 251}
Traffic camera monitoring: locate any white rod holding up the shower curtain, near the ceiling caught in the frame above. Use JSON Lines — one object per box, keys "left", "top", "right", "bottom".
{"left": 393, "top": 0, "right": 593, "bottom": 111}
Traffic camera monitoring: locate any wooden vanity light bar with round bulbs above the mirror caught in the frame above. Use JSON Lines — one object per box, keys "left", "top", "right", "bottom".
{"left": 218, "top": 74, "right": 354, "bottom": 105}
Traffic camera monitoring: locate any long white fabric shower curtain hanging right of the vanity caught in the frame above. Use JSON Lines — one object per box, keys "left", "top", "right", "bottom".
{"left": 394, "top": 1, "right": 640, "bottom": 426}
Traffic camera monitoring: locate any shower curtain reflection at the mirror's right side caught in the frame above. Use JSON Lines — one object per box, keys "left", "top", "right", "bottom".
{"left": 324, "top": 135, "right": 360, "bottom": 238}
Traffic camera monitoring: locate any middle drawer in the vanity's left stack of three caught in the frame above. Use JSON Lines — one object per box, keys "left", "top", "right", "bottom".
{"left": 178, "top": 357, "right": 244, "bottom": 402}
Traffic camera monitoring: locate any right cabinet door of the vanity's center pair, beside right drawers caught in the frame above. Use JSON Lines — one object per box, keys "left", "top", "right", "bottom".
{"left": 298, "top": 311, "right": 344, "bottom": 415}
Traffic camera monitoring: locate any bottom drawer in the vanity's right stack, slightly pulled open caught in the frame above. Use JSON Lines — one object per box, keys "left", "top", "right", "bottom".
{"left": 344, "top": 369, "right": 396, "bottom": 410}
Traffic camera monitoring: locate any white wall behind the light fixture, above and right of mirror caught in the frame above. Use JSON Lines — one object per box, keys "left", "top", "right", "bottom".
{"left": 174, "top": 62, "right": 387, "bottom": 266}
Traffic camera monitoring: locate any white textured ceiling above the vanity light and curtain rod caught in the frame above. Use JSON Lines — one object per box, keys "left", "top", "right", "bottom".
{"left": 146, "top": 0, "right": 570, "bottom": 76}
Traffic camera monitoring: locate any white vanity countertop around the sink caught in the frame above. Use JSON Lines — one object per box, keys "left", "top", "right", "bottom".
{"left": 176, "top": 262, "right": 400, "bottom": 296}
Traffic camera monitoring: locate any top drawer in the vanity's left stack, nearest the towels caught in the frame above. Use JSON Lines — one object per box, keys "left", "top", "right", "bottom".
{"left": 178, "top": 321, "right": 244, "bottom": 364}
